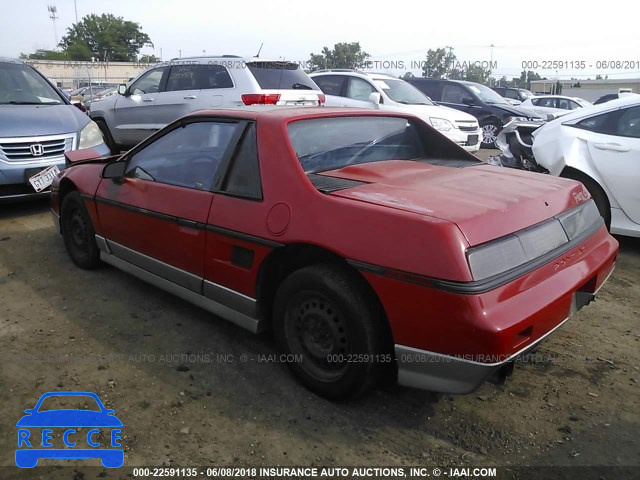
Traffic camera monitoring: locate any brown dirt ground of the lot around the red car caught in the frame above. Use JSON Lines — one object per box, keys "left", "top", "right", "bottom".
{"left": 0, "top": 163, "right": 640, "bottom": 479}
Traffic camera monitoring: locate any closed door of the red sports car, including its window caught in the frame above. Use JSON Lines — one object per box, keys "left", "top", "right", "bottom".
{"left": 96, "top": 118, "right": 245, "bottom": 293}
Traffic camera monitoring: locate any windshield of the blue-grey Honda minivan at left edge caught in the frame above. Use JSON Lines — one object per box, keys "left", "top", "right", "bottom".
{"left": 0, "top": 63, "right": 63, "bottom": 105}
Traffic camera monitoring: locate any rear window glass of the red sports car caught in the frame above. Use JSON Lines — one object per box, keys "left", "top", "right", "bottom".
{"left": 288, "top": 117, "right": 426, "bottom": 173}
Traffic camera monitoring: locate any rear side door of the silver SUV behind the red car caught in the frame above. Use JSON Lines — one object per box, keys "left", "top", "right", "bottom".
{"left": 154, "top": 64, "right": 206, "bottom": 127}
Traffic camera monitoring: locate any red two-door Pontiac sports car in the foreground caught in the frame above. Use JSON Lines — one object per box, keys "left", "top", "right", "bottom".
{"left": 51, "top": 108, "right": 618, "bottom": 398}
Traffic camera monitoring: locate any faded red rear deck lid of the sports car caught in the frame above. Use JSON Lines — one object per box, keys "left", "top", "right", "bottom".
{"left": 322, "top": 160, "right": 589, "bottom": 246}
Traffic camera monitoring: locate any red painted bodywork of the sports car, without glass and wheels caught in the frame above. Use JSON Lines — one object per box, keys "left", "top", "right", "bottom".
{"left": 52, "top": 107, "right": 618, "bottom": 364}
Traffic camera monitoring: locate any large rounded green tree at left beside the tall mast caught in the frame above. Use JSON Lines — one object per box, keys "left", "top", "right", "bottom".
{"left": 59, "top": 14, "right": 151, "bottom": 62}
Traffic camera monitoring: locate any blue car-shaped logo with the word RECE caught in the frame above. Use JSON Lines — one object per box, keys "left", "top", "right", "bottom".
{"left": 16, "top": 391, "right": 124, "bottom": 468}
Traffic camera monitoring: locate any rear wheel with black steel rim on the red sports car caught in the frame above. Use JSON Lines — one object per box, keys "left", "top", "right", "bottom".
{"left": 273, "top": 263, "right": 391, "bottom": 400}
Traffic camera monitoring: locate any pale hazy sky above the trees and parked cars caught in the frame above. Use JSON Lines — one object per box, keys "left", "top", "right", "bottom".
{"left": 0, "top": 0, "right": 640, "bottom": 79}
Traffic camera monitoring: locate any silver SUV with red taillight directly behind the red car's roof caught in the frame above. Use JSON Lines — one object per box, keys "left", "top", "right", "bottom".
{"left": 91, "top": 55, "right": 324, "bottom": 150}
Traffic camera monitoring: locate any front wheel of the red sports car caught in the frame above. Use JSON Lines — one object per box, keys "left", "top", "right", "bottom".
{"left": 60, "top": 192, "right": 101, "bottom": 270}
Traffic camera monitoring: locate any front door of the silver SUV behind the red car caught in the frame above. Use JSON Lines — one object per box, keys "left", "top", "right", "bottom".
{"left": 111, "top": 67, "right": 169, "bottom": 146}
